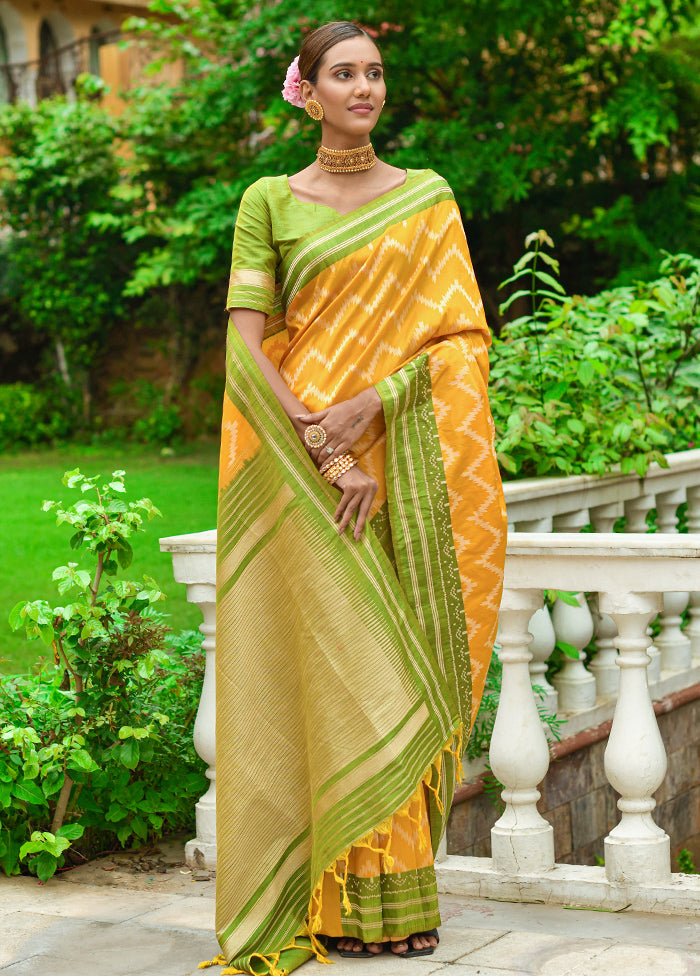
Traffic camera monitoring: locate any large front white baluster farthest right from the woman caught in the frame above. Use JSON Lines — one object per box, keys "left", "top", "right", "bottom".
{"left": 600, "top": 593, "right": 671, "bottom": 884}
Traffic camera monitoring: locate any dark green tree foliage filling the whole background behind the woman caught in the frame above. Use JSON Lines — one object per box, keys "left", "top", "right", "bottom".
{"left": 0, "top": 0, "right": 700, "bottom": 458}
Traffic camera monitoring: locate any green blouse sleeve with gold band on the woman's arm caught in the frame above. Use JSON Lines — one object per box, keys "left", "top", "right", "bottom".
{"left": 226, "top": 180, "right": 277, "bottom": 315}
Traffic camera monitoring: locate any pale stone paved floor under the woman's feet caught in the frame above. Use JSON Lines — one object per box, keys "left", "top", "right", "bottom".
{"left": 0, "top": 873, "right": 700, "bottom": 976}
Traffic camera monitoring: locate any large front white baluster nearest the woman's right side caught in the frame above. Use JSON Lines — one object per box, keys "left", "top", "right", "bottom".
{"left": 489, "top": 589, "right": 554, "bottom": 875}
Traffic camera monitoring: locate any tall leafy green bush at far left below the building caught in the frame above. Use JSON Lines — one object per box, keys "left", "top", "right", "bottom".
{"left": 0, "top": 98, "right": 135, "bottom": 418}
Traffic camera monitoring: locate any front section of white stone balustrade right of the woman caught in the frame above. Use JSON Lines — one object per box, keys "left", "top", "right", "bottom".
{"left": 438, "top": 533, "right": 700, "bottom": 913}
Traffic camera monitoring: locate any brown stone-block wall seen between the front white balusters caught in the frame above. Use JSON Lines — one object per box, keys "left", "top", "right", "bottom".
{"left": 447, "top": 698, "right": 700, "bottom": 870}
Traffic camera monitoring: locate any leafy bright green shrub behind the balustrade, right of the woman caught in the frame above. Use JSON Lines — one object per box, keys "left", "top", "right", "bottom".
{"left": 491, "top": 231, "right": 700, "bottom": 477}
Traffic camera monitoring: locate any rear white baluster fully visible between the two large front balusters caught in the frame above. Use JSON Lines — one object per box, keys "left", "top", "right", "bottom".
{"left": 552, "top": 593, "right": 596, "bottom": 712}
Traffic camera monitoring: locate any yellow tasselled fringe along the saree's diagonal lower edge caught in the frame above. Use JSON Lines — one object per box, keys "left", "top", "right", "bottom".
{"left": 308, "top": 725, "right": 464, "bottom": 936}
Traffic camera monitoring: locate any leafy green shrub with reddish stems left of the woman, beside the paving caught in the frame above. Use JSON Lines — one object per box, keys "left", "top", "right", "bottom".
{"left": 0, "top": 470, "right": 205, "bottom": 880}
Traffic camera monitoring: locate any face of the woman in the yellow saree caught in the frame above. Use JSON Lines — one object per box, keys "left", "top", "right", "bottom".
{"left": 300, "top": 36, "right": 386, "bottom": 143}
